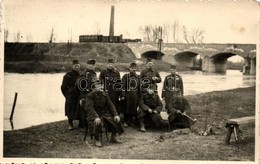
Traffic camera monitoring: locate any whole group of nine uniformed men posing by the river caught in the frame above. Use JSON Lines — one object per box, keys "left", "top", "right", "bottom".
{"left": 61, "top": 58, "right": 191, "bottom": 147}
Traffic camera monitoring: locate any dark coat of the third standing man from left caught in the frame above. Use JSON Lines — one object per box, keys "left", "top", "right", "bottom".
{"left": 99, "top": 69, "right": 122, "bottom": 113}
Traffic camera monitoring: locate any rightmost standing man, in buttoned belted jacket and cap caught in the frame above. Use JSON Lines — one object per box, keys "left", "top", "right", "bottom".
{"left": 162, "top": 65, "right": 183, "bottom": 109}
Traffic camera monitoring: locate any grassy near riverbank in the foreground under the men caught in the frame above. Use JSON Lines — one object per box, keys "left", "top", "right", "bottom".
{"left": 3, "top": 87, "right": 255, "bottom": 161}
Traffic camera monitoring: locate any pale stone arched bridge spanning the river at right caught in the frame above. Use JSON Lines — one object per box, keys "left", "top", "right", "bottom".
{"left": 127, "top": 43, "right": 256, "bottom": 74}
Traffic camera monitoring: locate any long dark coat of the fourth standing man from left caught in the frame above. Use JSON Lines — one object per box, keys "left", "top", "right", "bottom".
{"left": 121, "top": 73, "right": 140, "bottom": 115}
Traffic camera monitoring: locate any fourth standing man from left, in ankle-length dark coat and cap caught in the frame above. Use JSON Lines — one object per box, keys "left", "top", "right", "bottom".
{"left": 121, "top": 63, "right": 140, "bottom": 127}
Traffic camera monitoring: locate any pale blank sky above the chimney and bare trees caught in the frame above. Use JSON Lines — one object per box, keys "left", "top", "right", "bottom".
{"left": 2, "top": 0, "right": 259, "bottom": 43}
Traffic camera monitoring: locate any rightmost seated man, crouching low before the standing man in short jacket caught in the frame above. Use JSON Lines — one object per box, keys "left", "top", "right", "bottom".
{"left": 167, "top": 95, "right": 192, "bottom": 130}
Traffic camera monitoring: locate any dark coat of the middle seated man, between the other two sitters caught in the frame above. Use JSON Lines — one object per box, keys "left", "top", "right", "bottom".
{"left": 137, "top": 92, "right": 162, "bottom": 127}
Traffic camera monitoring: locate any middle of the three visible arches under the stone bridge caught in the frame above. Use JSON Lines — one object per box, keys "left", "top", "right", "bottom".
{"left": 174, "top": 51, "right": 199, "bottom": 67}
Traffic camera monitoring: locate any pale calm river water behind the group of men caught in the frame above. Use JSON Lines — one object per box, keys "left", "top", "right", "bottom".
{"left": 4, "top": 70, "right": 255, "bottom": 130}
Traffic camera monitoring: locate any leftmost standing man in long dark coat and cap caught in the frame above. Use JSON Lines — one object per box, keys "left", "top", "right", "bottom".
{"left": 61, "top": 60, "right": 80, "bottom": 130}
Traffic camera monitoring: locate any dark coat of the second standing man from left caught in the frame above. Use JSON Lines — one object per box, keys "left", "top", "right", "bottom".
{"left": 76, "top": 69, "right": 97, "bottom": 120}
